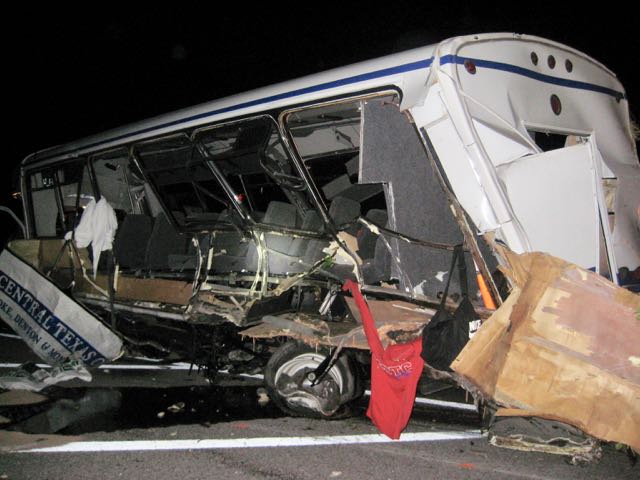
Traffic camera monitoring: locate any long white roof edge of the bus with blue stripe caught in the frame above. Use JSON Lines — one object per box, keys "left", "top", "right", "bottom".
{"left": 22, "top": 33, "right": 614, "bottom": 166}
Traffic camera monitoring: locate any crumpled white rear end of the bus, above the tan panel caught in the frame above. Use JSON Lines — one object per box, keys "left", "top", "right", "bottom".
{"left": 410, "top": 35, "right": 640, "bottom": 284}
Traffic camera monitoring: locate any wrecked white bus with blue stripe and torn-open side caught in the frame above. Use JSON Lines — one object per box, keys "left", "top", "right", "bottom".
{"left": 5, "top": 34, "right": 640, "bottom": 428}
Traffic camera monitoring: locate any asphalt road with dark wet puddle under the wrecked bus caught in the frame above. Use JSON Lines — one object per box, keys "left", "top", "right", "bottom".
{"left": 0, "top": 337, "right": 640, "bottom": 480}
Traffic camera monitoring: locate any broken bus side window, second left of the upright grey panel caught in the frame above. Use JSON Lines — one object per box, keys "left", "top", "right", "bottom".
{"left": 195, "top": 117, "right": 311, "bottom": 229}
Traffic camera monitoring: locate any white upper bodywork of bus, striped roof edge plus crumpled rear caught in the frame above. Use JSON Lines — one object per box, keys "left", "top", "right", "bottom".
{"left": 24, "top": 34, "right": 640, "bottom": 281}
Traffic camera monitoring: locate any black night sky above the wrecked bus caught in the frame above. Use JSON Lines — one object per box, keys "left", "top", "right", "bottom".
{"left": 0, "top": 1, "right": 640, "bottom": 236}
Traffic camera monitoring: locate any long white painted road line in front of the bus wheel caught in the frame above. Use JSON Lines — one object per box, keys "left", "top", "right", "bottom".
{"left": 17, "top": 430, "right": 482, "bottom": 453}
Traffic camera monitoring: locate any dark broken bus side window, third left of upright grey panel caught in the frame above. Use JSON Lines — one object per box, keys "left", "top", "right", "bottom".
{"left": 135, "top": 134, "right": 232, "bottom": 227}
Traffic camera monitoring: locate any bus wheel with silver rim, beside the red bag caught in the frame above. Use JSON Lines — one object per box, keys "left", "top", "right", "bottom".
{"left": 265, "top": 342, "right": 364, "bottom": 419}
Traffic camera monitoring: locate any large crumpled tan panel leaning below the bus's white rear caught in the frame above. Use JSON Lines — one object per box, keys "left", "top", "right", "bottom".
{"left": 451, "top": 248, "right": 640, "bottom": 451}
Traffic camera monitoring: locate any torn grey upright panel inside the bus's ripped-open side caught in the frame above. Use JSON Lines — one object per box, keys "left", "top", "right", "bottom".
{"left": 359, "top": 101, "right": 475, "bottom": 296}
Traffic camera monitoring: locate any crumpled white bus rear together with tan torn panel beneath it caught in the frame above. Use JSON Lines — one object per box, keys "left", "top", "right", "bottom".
{"left": 410, "top": 35, "right": 640, "bottom": 456}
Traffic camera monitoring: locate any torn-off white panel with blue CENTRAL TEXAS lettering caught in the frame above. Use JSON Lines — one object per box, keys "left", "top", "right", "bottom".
{"left": 0, "top": 250, "right": 122, "bottom": 367}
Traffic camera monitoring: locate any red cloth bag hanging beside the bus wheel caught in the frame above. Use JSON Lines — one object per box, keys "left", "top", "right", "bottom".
{"left": 343, "top": 280, "right": 424, "bottom": 440}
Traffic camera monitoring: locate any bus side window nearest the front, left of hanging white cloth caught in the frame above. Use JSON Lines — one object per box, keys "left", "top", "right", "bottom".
{"left": 29, "top": 160, "right": 94, "bottom": 237}
